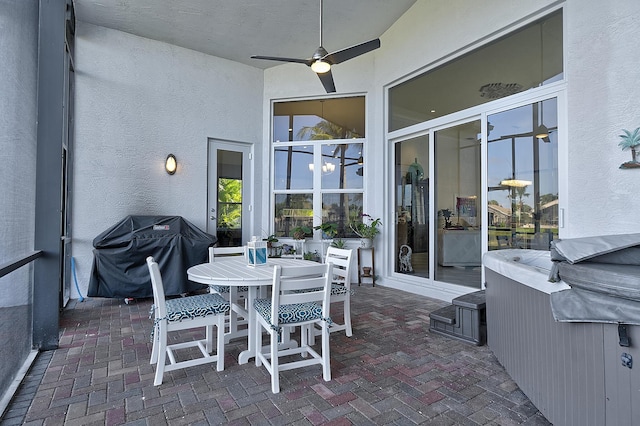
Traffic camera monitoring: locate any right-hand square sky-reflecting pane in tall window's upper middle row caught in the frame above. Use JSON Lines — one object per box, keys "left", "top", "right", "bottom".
{"left": 322, "top": 143, "right": 363, "bottom": 189}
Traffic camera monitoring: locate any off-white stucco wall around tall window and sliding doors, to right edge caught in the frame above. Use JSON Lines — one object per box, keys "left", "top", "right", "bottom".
{"left": 263, "top": 0, "right": 640, "bottom": 299}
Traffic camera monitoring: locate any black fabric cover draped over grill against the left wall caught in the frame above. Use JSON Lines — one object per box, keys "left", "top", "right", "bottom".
{"left": 87, "top": 216, "right": 217, "bottom": 298}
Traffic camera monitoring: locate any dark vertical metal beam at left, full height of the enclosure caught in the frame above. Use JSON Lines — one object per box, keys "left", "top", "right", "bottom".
{"left": 33, "top": 0, "right": 67, "bottom": 350}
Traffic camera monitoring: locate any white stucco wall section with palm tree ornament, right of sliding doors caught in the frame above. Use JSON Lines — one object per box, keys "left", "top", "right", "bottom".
{"left": 565, "top": 0, "right": 640, "bottom": 237}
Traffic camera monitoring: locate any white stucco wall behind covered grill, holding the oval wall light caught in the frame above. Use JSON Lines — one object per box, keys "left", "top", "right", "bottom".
{"left": 71, "top": 22, "right": 263, "bottom": 298}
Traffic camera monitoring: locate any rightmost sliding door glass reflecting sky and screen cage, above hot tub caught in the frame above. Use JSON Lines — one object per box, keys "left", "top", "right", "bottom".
{"left": 487, "top": 98, "right": 558, "bottom": 250}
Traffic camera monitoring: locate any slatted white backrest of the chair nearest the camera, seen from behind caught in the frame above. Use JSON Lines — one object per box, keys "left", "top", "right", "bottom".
{"left": 271, "top": 263, "right": 333, "bottom": 326}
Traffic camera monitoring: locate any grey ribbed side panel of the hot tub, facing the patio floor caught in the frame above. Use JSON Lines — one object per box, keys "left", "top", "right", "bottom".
{"left": 485, "top": 268, "right": 604, "bottom": 426}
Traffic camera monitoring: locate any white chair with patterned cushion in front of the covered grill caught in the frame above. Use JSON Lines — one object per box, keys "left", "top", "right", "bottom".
{"left": 147, "top": 256, "right": 229, "bottom": 386}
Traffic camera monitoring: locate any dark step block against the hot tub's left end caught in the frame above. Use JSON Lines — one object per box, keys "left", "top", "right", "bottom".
{"left": 429, "top": 290, "right": 487, "bottom": 346}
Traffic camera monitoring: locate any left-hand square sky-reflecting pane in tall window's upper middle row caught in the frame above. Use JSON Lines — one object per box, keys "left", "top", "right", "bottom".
{"left": 274, "top": 146, "right": 313, "bottom": 189}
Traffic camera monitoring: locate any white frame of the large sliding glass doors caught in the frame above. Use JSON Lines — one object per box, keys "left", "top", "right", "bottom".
{"left": 385, "top": 82, "right": 568, "bottom": 294}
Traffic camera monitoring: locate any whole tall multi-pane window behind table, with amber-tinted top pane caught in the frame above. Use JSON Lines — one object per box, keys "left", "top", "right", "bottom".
{"left": 272, "top": 97, "right": 365, "bottom": 238}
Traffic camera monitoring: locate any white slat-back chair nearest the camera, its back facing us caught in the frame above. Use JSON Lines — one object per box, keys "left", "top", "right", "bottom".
{"left": 253, "top": 263, "right": 333, "bottom": 393}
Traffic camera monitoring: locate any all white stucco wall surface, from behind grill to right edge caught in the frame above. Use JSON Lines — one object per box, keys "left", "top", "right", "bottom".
{"left": 73, "top": 0, "right": 640, "bottom": 297}
